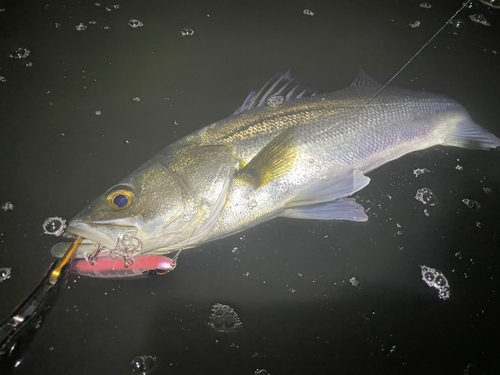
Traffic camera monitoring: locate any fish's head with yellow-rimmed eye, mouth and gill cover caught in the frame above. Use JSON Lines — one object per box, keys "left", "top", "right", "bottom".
{"left": 52, "top": 163, "right": 207, "bottom": 258}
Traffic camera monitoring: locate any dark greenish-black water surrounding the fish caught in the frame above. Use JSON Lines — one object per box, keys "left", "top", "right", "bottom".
{"left": 0, "top": 0, "right": 500, "bottom": 375}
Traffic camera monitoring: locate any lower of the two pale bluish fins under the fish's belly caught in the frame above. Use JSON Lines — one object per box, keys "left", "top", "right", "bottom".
{"left": 281, "top": 198, "right": 368, "bottom": 221}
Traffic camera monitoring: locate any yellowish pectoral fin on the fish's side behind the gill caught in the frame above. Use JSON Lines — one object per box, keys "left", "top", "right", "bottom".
{"left": 235, "top": 126, "right": 299, "bottom": 189}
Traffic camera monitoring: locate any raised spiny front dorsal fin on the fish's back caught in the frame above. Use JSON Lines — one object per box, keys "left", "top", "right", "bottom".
{"left": 233, "top": 70, "right": 317, "bottom": 115}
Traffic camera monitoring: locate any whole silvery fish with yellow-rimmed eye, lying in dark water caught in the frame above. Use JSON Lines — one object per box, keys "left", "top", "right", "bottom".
{"left": 51, "top": 70, "right": 500, "bottom": 261}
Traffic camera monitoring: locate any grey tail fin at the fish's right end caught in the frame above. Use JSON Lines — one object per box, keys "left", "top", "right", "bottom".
{"left": 443, "top": 120, "right": 500, "bottom": 150}
